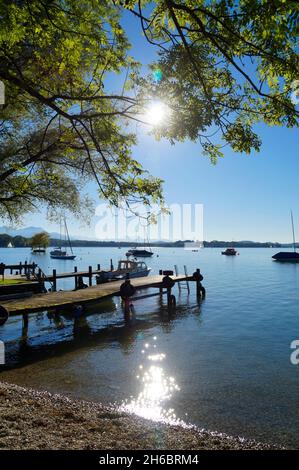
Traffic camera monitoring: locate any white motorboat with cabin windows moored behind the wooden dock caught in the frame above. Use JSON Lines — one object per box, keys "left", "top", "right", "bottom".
{"left": 96, "top": 259, "right": 151, "bottom": 284}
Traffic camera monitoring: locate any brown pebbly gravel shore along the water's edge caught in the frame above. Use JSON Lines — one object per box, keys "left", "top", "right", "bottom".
{"left": 0, "top": 382, "right": 276, "bottom": 450}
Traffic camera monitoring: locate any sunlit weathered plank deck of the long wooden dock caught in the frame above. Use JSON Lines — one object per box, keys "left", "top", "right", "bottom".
{"left": 1, "top": 275, "right": 194, "bottom": 315}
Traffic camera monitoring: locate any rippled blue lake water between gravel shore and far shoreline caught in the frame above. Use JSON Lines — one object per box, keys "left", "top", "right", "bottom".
{"left": 0, "top": 248, "right": 299, "bottom": 447}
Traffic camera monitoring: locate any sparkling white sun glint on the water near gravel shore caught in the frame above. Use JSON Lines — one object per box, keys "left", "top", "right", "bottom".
{"left": 120, "top": 337, "right": 186, "bottom": 426}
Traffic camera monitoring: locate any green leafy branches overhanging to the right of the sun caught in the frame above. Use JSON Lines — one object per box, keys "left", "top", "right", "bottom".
{"left": 119, "top": 0, "right": 299, "bottom": 162}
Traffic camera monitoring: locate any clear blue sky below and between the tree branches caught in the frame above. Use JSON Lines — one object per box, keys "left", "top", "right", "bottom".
{"left": 24, "top": 10, "right": 299, "bottom": 242}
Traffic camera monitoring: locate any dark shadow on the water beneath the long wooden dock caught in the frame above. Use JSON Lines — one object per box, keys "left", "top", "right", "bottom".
{"left": 0, "top": 295, "right": 204, "bottom": 372}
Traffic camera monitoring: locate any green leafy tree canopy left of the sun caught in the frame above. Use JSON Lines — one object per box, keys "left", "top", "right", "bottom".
{"left": 0, "top": 0, "right": 162, "bottom": 219}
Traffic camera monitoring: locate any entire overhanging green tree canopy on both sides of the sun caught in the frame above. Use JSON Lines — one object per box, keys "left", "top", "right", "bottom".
{"left": 0, "top": 0, "right": 299, "bottom": 220}
